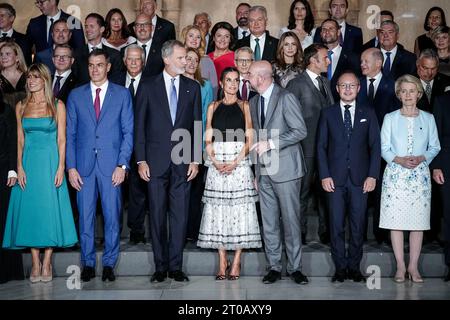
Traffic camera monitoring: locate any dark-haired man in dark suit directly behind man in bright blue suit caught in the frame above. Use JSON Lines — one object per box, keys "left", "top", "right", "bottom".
{"left": 74, "top": 13, "right": 125, "bottom": 85}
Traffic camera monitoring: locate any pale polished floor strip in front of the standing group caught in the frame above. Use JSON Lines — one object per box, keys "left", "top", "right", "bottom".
{"left": 0, "top": 276, "right": 450, "bottom": 300}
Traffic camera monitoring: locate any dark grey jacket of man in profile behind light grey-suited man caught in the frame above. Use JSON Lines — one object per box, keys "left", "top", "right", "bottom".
{"left": 286, "top": 71, "right": 334, "bottom": 158}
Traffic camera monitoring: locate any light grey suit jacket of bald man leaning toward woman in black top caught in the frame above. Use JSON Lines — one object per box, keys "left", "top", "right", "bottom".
{"left": 250, "top": 84, "right": 306, "bottom": 183}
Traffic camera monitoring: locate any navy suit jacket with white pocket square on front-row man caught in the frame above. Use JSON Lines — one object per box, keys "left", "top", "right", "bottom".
{"left": 317, "top": 103, "right": 381, "bottom": 186}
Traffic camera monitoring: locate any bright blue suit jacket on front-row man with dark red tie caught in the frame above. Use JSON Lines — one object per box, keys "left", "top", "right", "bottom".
{"left": 66, "top": 82, "right": 134, "bottom": 177}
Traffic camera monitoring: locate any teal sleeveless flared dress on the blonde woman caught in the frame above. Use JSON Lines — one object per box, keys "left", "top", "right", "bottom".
{"left": 3, "top": 117, "right": 78, "bottom": 249}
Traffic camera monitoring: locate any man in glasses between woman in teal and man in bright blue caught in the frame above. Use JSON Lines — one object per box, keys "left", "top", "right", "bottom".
{"left": 52, "top": 44, "right": 77, "bottom": 103}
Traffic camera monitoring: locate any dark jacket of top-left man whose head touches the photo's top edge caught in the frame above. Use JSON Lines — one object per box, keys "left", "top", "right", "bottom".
{"left": 26, "top": 10, "right": 84, "bottom": 52}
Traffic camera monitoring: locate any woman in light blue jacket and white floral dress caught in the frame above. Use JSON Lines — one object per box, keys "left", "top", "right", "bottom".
{"left": 380, "top": 75, "right": 440, "bottom": 282}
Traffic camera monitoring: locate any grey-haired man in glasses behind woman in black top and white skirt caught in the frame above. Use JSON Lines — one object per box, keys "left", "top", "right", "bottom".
{"left": 234, "top": 47, "right": 257, "bottom": 101}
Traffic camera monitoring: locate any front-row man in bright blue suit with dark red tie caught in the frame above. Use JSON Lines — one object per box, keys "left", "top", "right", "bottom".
{"left": 66, "top": 49, "right": 134, "bottom": 281}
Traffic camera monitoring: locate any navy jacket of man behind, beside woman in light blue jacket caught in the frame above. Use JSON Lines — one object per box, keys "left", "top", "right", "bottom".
{"left": 358, "top": 76, "right": 401, "bottom": 128}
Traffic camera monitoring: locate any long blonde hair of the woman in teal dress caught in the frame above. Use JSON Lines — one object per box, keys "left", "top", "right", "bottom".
{"left": 20, "top": 63, "right": 56, "bottom": 120}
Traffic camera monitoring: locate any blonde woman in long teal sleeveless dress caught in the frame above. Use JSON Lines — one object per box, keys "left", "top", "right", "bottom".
{"left": 3, "top": 64, "right": 78, "bottom": 282}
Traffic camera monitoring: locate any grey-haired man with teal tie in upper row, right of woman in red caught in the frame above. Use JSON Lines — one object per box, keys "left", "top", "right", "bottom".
{"left": 236, "top": 6, "right": 278, "bottom": 62}
